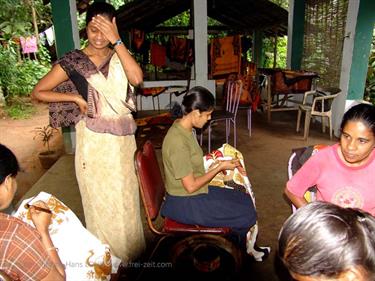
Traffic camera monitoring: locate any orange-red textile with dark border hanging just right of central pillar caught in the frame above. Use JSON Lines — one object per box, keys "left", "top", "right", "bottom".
{"left": 211, "top": 35, "right": 241, "bottom": 76}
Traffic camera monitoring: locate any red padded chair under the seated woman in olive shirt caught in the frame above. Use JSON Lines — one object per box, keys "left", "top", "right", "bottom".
{"left": 134, "top": 141, "right": 242, "bottom": 272}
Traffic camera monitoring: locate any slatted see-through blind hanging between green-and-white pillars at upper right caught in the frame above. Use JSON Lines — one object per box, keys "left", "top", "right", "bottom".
{"left": 302, "top": 0, "right": 348, "bottom": 87}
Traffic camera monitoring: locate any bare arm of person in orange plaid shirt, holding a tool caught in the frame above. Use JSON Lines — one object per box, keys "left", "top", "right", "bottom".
{"left": 30, "top": 201, "right": 66, "bottom": 281}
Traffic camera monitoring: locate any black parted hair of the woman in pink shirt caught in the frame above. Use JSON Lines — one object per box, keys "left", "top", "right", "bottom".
{"left": 340, "top": 103, "right": 375, "bottom": 136}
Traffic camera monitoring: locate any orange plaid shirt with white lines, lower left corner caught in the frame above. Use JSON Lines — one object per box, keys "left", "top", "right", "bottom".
{"left": 0, "top": 213, "right": 53, "bottom": 280}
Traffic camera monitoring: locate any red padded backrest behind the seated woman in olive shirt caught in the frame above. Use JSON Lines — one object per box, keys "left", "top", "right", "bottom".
{"left": 134, "top": 140, "right": 165, "bottom": 229}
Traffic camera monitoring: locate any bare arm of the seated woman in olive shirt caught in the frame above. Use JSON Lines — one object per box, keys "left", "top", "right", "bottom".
{"left": 182, "top": 160, "right": 241, "bottom": 193}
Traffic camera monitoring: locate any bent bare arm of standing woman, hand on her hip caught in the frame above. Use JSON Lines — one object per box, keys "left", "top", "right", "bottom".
{"left": 32, "top": 64, "right": 87, "bottom": 113}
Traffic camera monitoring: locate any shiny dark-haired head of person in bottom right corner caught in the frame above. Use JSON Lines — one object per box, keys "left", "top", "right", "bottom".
{"left": 279, "top": 201, "right": 375, "bottom": 281}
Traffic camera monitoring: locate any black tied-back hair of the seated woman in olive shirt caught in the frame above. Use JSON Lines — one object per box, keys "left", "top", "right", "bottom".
{"left": 182, "top": 86, "right": 215, "bottom": 115}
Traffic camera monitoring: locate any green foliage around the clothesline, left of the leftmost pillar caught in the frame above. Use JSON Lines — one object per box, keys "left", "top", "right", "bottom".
{"left": 0, "top": 0, "right": 51, "bottom": 100}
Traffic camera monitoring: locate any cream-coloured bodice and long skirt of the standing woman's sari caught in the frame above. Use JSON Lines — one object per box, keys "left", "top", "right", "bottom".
{"left": 75, "top": 54, "right": 145, "bottom": 262}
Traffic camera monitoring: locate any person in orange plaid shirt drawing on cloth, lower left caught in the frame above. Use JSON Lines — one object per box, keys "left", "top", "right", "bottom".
{"left": 0, "top": 144, "right": 65, "bottom": 281}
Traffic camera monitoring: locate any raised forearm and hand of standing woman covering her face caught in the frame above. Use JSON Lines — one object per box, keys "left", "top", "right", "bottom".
{"left": 92, "top": 15, "right": 143, "bottom": 86}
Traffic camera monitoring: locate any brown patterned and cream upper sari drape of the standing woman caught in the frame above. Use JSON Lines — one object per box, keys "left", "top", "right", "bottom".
{"left": 49, "top": 50, "right": 136, "bottom": 135}
